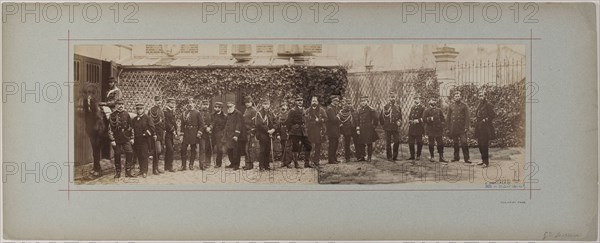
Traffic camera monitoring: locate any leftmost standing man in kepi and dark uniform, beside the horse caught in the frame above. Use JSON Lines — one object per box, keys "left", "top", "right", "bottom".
{"left": 108, "top": 99, "right": 133, "bottom": 178}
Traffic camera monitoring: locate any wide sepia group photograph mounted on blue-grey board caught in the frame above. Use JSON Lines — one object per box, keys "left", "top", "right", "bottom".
{"left": 73, "top": 44, "right": 526, "bottom": 187}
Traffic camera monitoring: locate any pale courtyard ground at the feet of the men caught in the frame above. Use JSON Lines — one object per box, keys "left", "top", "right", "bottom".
{"left": 75, "top": 148, "right": 526, "bottom": 185}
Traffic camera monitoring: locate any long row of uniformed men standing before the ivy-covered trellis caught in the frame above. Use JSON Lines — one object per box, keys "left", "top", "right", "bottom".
{"left": 95, "top": 80, "right": 495, "bottom": 178}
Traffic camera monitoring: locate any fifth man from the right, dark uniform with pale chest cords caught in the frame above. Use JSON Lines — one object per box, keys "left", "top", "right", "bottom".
{"left": 379, "top": 92, "right": 402, "bottom": 161}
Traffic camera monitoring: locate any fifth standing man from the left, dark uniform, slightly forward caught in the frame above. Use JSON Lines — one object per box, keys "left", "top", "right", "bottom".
{"left": 180, "top": 98, "right": 204, "bottom": 170}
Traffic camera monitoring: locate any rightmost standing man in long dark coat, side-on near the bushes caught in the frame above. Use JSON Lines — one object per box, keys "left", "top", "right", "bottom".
{"left": 475, "top": 91, "right": 496, "bottom": 168}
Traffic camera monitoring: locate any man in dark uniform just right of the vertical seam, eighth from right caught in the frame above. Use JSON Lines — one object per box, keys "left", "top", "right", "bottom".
{"left": 325, "top": 95, "right": 341, "bottom": 164}
